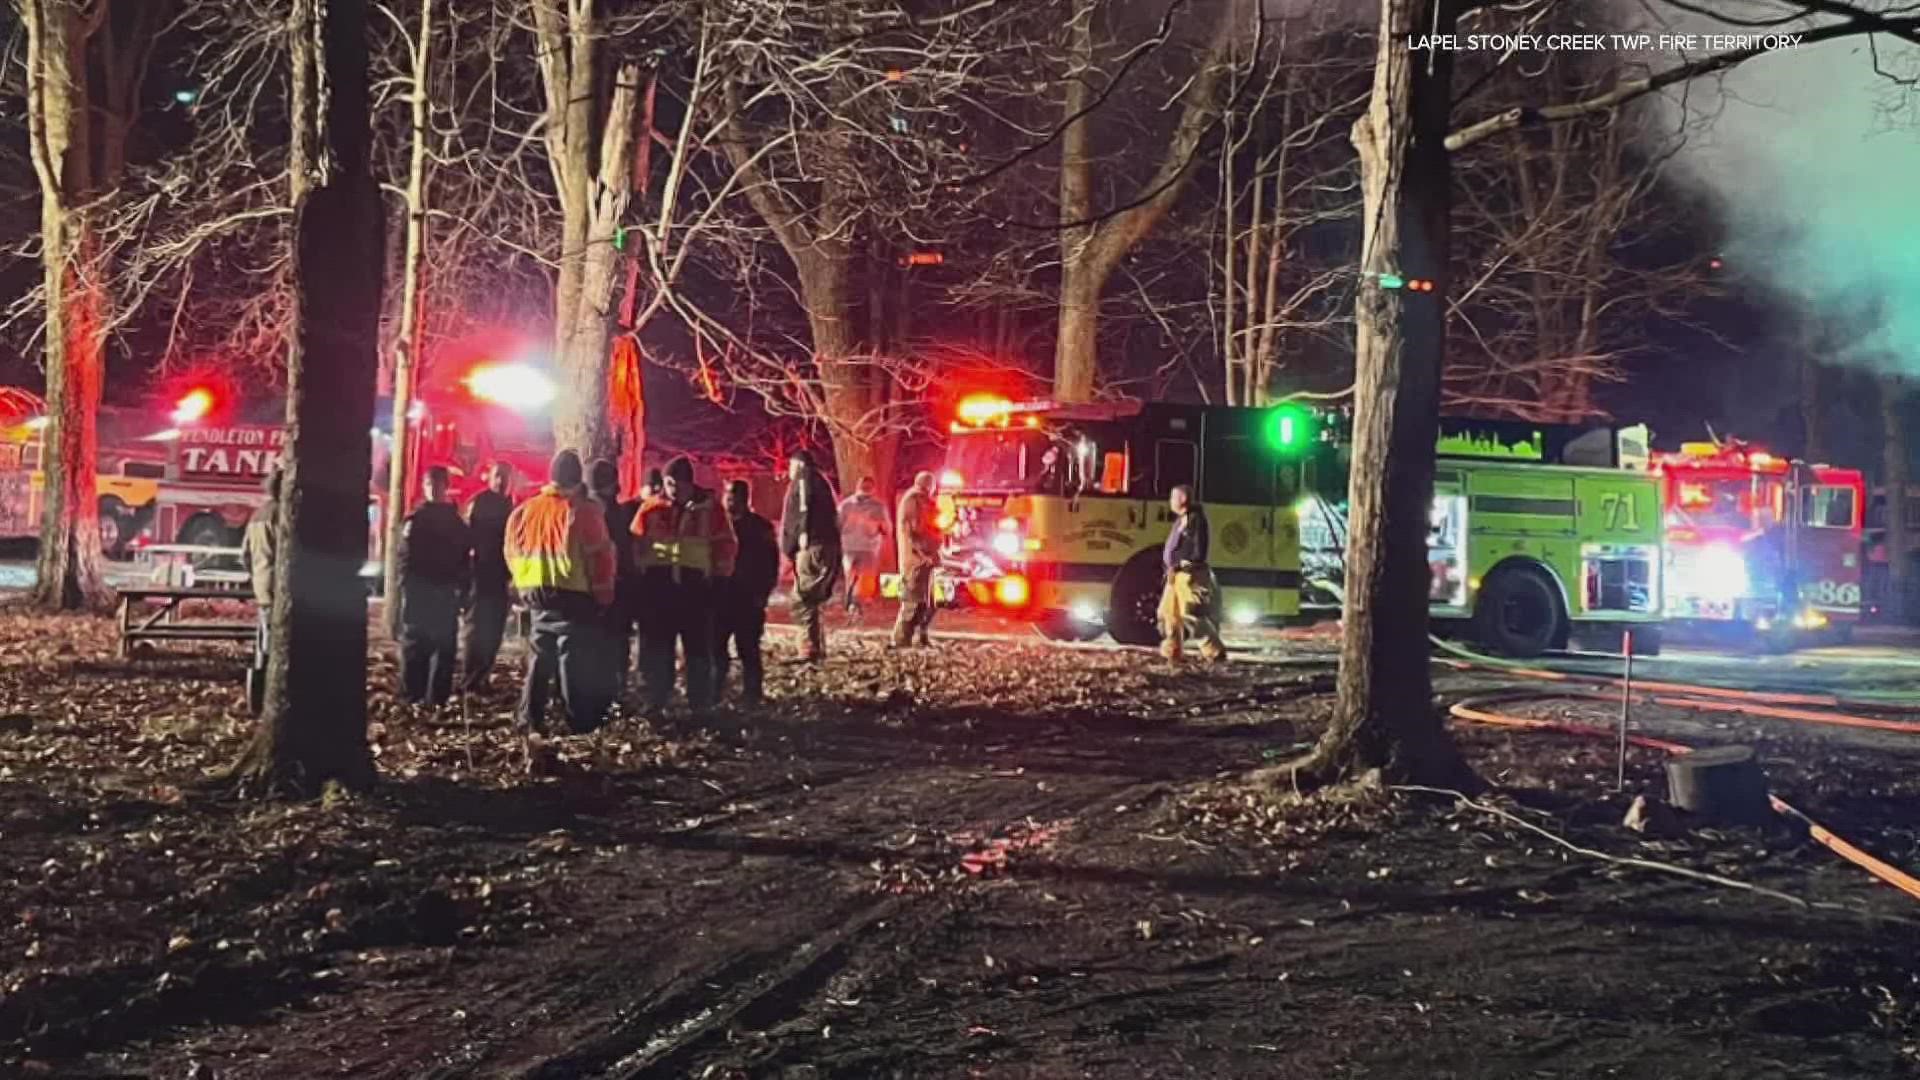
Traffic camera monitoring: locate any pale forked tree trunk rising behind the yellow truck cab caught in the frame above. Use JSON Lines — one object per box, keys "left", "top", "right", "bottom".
{"left": 1054, "top": 0, "right": 1235, "bottom": 402}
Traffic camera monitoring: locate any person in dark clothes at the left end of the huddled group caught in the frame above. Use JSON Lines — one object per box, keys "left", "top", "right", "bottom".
{"left": 399, "top": 465, "right": 472, "bottom": 705}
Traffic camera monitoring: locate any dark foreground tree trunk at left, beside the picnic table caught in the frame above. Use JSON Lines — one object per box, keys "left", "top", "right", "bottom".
{"left": 236, "top": 0, "right": 384, "bottom": 794}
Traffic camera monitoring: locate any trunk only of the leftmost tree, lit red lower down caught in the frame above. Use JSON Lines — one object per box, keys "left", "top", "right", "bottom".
{"left": 19, "top": 0, "right": 109, "bottom": 609}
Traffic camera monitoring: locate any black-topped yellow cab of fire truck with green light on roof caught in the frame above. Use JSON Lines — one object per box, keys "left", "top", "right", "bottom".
{"left": 937, "top": 396, "right": 1311, "bottom": 644}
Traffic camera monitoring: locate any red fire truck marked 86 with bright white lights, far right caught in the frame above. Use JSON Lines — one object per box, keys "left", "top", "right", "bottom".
{"left": 1653, "top": 440, "right": 1866, "bottom": 644}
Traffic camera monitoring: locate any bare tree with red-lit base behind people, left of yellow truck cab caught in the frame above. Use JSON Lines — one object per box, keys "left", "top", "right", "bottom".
{"left": 705, "top": 0, "right": 1031, "bottom": 486}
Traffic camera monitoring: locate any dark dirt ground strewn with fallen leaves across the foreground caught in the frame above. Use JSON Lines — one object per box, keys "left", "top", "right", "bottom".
{"left": 0, "top": 615, "right": 1920, "bottom": 1080}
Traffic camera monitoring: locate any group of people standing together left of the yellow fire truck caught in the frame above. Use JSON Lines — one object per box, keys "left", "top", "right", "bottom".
{"left": 382, "top": 441, "right": 941, "bottom": 732}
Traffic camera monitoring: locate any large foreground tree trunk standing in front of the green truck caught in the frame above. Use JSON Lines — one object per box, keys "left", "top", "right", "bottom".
{"left": 1275, "top": 0, "right": 1467, "bottom": 788}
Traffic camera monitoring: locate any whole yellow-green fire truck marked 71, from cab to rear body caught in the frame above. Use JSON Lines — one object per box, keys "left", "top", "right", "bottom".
{"left": 939, "top": 390, "right": 1661, "bottom": 655}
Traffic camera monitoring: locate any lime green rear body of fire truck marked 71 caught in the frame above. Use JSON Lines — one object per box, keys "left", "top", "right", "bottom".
{"left": 1300, "top": 419, "right": 1663, "bottom": 657}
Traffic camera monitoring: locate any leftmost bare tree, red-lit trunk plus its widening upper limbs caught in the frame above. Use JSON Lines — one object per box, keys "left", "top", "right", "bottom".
{"left": 15, "top": 0, "right": 171, "bottom": 607}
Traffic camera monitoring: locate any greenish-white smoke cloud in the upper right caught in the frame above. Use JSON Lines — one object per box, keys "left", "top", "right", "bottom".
{"left": 1635, "top": 6, "right": 1920, "bottom": 373}
